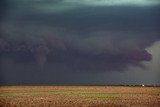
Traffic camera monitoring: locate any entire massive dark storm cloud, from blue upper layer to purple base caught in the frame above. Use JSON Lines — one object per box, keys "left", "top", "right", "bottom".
{"left": 0, "top": 0, "right": 160, "bottom": 81}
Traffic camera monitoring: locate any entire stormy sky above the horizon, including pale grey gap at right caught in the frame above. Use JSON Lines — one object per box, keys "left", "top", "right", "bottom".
{"left": 0, "top": 0, "right": 160, "bottom": 85}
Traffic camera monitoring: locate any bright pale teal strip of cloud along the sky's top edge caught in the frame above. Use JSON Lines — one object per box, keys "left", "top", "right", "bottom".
{"left": 9, "top": 0, "right": 160, "bottom": 13}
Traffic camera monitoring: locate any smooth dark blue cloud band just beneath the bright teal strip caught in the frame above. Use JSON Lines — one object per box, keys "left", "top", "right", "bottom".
{"left": 4, "top": 6, "right": 160, "bottom": 31}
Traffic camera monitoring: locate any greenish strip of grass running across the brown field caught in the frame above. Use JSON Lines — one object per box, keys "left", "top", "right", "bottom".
{"left": 0, "top": 90, "right": 160, "bottom": 98}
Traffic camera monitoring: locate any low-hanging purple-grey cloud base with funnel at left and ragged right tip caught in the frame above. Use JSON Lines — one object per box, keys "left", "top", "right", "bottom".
{"left": 0, "top": 26, "right": 157, "bottom": 72}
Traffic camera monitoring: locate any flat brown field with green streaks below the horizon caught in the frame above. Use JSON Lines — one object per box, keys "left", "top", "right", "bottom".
{"left": 0, "top": 86, "right": 160, "bottom": 107}
